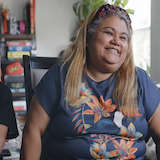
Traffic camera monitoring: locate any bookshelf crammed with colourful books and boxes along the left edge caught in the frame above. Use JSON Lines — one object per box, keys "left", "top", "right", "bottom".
{"left": 0, "top": 0, "right": 36, "bottom": 160}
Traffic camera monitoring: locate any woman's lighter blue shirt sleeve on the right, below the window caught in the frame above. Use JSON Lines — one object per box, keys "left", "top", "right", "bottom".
{"left": 138, "top": 68, "right": 160, "bottom": 120}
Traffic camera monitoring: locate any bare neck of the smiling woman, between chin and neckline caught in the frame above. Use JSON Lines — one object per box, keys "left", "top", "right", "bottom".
{"left": 87, "top": 68, "right": 112, "bottom": 82}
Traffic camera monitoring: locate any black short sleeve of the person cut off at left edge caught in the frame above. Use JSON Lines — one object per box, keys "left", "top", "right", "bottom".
{"left": 0, "top": 83, "right": 18, "bottom": 139}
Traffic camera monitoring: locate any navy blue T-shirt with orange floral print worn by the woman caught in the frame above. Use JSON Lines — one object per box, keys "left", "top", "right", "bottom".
{"left": 35, "top": 64, "right": 160, "bottom": 160}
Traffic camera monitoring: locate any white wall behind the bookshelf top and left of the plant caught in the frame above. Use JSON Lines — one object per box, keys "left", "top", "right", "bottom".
{"left": 0, "top": 0, "right": 76, "bottom": 56}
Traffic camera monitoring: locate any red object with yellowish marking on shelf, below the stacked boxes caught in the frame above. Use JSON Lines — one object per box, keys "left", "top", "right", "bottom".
{"left": 6, "top": 62, "right": 24, "bottom": 76}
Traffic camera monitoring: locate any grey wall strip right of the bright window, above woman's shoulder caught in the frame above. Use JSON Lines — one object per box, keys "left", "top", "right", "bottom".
{"left": 151, "top": 0, "right": 160, "bottom": 83}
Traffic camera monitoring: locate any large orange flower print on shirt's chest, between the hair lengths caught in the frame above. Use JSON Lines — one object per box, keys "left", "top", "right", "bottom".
{"left": 83, "top": 95, "right": 116, "bottom": 123}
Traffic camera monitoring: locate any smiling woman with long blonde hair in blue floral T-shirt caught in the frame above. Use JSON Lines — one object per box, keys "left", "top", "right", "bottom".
{"left": 21, "top": 4, "right": 160, "bottom": 160}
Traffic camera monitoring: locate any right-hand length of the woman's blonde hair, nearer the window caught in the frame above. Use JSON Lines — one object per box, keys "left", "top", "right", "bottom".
{"left": 113, "top": 26, "right": 138, "bottom": 117}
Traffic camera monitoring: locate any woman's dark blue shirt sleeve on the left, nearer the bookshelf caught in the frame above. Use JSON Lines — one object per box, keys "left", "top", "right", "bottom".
{"left": 34, "top": 64, "right": 61, "bottom": 117}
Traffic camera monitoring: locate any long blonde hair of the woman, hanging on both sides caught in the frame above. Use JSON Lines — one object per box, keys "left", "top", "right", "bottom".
{"left": 63, "top": 9, "right": 138, "bottom": 117}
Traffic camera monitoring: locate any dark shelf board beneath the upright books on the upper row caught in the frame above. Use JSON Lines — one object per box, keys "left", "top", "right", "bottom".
{"left": 0, "top": 34, "right": 35, "bottom": 40}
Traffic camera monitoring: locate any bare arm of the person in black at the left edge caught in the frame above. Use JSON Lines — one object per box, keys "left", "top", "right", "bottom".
{"left": 0, "top": 124, "right": 8, "bottom": 153}
